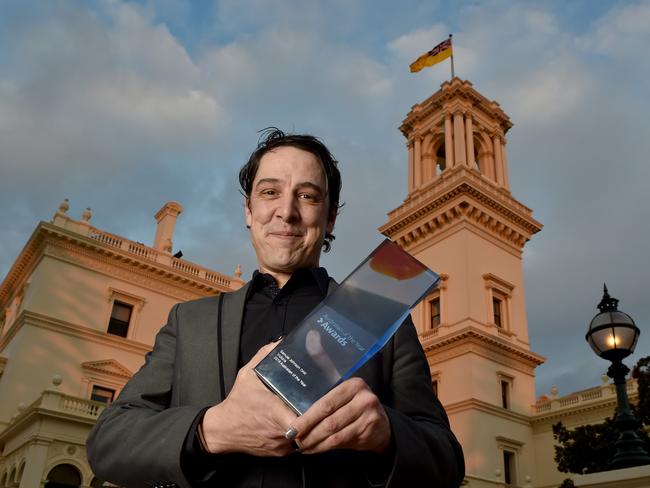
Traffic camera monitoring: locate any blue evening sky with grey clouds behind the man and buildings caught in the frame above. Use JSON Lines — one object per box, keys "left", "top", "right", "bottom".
{"left": 0, "top": 0, "right": 650, "bottom": 395}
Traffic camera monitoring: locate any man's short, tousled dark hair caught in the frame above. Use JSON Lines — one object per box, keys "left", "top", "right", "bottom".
{"left": 239, "top": 127, "right": 343, "bottom": 252}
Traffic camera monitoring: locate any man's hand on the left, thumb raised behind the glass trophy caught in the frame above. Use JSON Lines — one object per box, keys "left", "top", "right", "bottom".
{"left": 202, "top": 343, "right": 296, "bottom": 456}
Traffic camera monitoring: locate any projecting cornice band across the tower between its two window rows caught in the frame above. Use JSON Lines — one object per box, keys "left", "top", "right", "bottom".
{"left": 422, "top": 326, "right": 546, "bottom": 373}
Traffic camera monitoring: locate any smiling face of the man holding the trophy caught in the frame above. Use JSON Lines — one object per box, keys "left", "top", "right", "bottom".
{"left": 246, "top": 146, "right": 335, "bottom": 284}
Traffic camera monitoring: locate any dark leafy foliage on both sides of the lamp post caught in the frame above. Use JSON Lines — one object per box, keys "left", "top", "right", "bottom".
{"left": 553, "top": 356, "right": 650, "bottom": 474}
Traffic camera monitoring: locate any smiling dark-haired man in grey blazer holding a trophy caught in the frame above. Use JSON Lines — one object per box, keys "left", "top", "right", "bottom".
{"left": 88, "top": 130, "right": 464, "bottom": 488}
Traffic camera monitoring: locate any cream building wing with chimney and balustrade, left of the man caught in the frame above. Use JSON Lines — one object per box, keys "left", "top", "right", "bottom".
{"left": 0, "top": 201, "right": 243, "bottom": 488}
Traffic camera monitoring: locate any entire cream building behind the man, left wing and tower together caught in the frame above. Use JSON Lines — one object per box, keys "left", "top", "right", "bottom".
{"left": 0, "top": 78, "right": 648, "bottom": 488}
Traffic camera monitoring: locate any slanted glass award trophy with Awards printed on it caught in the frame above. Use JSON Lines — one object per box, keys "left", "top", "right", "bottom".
{"left": 254, "top": 239, "right": 440, "bottom": 415}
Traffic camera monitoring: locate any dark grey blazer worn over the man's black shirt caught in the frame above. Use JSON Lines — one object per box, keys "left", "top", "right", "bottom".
{"left": 87, "top": 282, "right": 464, "bottom": 488}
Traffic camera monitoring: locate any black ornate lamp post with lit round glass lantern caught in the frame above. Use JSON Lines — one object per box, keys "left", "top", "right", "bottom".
{"left": 586, "top": 285, "right": 650, "bottom": 469}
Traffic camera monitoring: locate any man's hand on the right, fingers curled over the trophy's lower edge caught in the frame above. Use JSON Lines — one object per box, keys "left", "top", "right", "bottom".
{"left": 291, "top": 378, "right": 391, "bottom": 454}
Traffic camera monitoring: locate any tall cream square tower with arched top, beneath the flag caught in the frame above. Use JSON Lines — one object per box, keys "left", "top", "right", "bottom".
{"left": 380, "top": 78, "right": 544, "bottom": 487}
